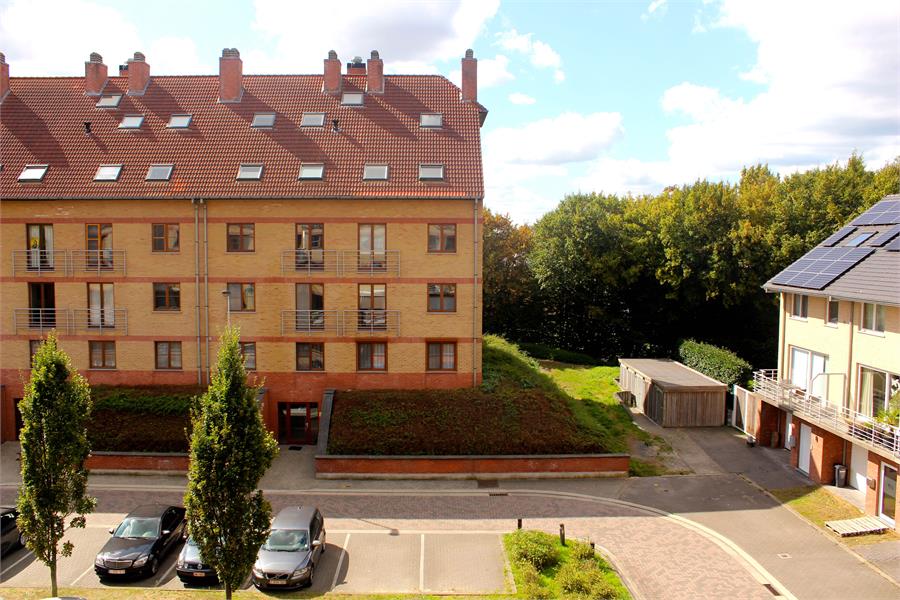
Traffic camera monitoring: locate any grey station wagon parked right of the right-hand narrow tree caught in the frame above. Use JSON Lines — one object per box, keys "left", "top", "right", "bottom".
{"left": 253, "top": 506, "right": 325, "bottom": 589}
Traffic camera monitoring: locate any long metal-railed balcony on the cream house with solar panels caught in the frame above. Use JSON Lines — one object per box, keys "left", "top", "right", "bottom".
{"left": 753, "top": 369, "right": 900, "bottom": 459}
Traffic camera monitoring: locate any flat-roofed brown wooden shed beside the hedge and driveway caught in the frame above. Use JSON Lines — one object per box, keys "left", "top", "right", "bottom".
{"left": 619, "top": 358, "right": 728, "bottom": 427}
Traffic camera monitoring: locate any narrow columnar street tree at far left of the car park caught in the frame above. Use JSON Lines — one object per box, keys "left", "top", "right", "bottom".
{"left": 18, "top": 333, "right": 96, "bottom": 596}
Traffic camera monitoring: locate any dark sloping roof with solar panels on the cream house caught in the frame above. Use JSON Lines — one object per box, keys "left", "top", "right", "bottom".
{"left": 763, "top": 194, "right": 900, "bottom": 306}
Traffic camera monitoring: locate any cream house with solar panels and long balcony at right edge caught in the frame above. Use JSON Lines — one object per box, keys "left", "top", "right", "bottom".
{"left": 734, "top": 195, "right": 900, "bottom": 527}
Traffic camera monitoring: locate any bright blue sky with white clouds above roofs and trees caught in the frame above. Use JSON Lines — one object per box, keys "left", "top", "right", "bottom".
{"left": 0, "top": 0, "right": 900, "bottom": 222}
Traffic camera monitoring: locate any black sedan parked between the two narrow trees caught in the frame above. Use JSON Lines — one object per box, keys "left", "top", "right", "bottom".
{"left": 94, "top": 504, "right": 185, "bottom": 579}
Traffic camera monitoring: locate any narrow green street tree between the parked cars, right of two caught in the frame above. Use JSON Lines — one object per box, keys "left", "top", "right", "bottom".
{"left": 184, "top": 327, "right": 278, "bottom": 599}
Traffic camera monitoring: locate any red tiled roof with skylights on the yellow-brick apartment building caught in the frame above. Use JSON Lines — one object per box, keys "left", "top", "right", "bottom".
{"left": 0, "top": 75, "right": 484, "bottom": 199}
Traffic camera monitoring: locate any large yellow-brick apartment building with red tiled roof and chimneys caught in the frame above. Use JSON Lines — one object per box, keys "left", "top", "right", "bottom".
{"left": 0, "top": 49, "right": 487, "bottom": 443}
